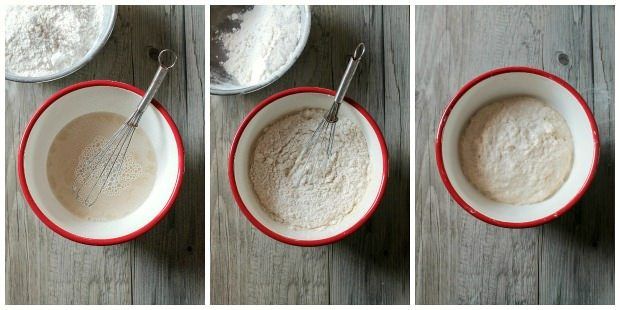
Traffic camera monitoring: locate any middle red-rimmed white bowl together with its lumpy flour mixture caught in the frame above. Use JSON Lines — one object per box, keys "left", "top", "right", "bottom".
{"left": 228, "top": 87, "right": 388, "bottom": 246}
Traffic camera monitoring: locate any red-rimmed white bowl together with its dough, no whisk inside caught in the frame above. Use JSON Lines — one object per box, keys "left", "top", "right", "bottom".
{"left": 435, "top": 67, "right": 599, "bottom": 228}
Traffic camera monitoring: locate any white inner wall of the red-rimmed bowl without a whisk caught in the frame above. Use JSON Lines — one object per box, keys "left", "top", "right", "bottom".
{"left": 441, "top": 72, "right": 596, "bottom": 223}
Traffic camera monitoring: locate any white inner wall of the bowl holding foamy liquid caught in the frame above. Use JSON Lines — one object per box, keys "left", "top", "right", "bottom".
{"left": 24, "top": 86, "right": 181, "bottom": 239}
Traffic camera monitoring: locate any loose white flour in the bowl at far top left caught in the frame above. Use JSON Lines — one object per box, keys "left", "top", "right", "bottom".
{"left": 5, "top": 5, "right": 103, "bottom": 77}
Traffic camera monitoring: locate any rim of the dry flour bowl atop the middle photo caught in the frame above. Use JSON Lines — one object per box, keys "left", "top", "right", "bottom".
{"left": 210, "top": 5, "right": 312, "bottom": 96}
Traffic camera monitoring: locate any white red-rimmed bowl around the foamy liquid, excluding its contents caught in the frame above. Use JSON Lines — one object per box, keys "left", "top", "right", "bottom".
{"left": 17, "top": 80, "right": 185, "bottom": 245}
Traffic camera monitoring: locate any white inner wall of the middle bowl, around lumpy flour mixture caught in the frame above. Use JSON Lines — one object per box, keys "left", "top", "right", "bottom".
{"left": 233, "top": 93, "right": 384, "bottom": 241}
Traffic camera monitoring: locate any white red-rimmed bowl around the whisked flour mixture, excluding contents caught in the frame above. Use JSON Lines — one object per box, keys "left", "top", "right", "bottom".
{"left": 228, "top": 87, "right": 388, "bottom": 246}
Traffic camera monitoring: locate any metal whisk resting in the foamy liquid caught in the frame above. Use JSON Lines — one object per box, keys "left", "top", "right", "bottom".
{"left": 73, "top": 49, "right": 177, "bottom": 208}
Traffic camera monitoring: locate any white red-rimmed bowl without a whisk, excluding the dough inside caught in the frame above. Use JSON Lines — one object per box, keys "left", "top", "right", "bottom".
{"left": 435, "top": 67, "right": 599, "bottom": 228}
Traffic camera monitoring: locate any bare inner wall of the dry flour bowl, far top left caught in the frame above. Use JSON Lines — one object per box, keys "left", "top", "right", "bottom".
{"left": 5, "top": 5, "right": 116, "bottom": 82}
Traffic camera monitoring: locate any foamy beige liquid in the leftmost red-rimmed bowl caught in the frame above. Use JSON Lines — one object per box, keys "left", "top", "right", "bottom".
{"left": 46, "top": 112, "right": 157, "bottom": 221}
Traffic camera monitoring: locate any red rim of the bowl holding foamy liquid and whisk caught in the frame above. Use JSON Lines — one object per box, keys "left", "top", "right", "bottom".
{"left": 17, "top": 80, "right": 185, "bottom": 245}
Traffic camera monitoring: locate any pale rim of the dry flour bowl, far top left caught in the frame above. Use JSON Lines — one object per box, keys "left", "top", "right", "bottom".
{"left": 4, "top": 5, "right": 118, "bottom": 83}
